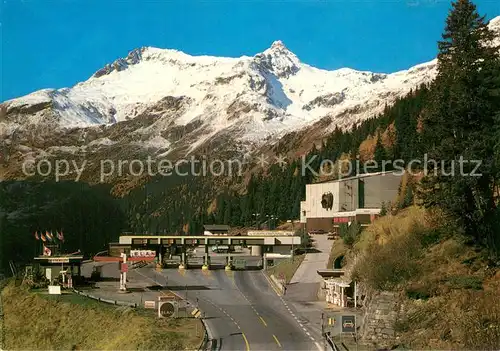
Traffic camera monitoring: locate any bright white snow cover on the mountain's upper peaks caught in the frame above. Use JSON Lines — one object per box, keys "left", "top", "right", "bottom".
{"left": 0, "top": 41, "right": 435, "bottom": 140}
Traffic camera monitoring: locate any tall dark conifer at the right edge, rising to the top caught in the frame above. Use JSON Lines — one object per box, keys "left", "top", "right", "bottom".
{"left": 422, "top": 0, "right": 500, "bottom": 253}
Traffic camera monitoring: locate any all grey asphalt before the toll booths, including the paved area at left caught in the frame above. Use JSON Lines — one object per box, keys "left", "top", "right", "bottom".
{"left": 84, "top": 263, "right": 319, "bottom": 350}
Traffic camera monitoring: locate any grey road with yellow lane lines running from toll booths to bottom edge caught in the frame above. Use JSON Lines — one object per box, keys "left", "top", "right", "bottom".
{"left": 156, "top": 269, "right": 317, "bottom": 350}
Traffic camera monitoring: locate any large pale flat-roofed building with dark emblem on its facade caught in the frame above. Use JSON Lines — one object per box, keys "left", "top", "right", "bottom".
{"left": 300, "top": 172, "right": 402, "bottom": 234}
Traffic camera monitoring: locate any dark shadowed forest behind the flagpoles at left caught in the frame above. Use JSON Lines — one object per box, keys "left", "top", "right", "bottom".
{"left": 0, "top": 181, "right": 125, "bottom": 270}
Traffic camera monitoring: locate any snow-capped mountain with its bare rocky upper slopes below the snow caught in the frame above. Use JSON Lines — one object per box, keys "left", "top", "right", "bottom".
{"left": 0, "top": 17, "right": 500, "bottom": 182}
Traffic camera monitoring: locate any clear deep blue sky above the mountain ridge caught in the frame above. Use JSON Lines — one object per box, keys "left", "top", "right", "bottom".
{"left": 0, "top": 0, "right": 500, "bottom": 101}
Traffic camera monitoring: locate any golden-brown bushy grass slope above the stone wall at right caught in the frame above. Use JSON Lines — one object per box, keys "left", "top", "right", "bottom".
{"left": 354, "top": 207, "right": 500, "bottom": 350}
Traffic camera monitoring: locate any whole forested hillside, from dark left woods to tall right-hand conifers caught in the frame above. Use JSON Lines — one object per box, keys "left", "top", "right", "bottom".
{"left": 0, "top": 0, "right": 500, "bottom": 276}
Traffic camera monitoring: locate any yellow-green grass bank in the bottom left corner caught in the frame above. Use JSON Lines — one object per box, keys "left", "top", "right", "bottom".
{"left": 2, "top": 284, "right": 203, "bottom": 350}
